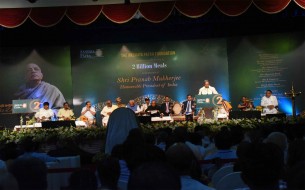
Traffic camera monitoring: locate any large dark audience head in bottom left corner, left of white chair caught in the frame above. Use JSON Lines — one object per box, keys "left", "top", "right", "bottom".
{"left": 8, "top": 157, "right": 47, "bottom": 190}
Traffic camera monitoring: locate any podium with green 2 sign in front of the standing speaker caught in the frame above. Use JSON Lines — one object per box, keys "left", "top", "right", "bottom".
{"left": 195, "top": 94, "right": 222, "bottom": 119}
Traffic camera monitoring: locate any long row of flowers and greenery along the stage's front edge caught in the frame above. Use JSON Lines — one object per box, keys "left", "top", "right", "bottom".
{"left": 0, "top": 118, "right": 305, "bottom": 147}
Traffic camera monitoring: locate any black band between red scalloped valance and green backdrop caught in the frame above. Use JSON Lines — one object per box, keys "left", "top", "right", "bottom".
{"left": 0, "top": 3, "right": 305, "bottom": 47}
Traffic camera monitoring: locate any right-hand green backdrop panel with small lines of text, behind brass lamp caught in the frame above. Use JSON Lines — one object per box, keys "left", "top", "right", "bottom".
{"left": 228, "top": 33, "right": 305, "bottom": 115}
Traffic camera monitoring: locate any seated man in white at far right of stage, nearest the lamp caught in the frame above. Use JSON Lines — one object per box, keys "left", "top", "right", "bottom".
{"left": 261, "top": 90, "right": 279, "bottom": 114}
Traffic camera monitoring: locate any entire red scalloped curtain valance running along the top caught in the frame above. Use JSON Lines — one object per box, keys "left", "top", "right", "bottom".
{"left": 0, "top": 0, "right": 305, "bottom": 28}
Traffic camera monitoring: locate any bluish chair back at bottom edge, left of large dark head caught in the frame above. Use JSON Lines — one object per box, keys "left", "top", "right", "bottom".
{"left": 215, "top": 172, "right": 248, "bottom": 190}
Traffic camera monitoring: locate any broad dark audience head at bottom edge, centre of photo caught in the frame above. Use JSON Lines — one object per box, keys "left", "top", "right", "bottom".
{"left": 128, "top": 162, "right": 181, "bottom": 190}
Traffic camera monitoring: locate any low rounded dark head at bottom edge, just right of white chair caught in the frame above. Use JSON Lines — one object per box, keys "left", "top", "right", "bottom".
{"left": 69, "top": 169, "right": 97, "bottom": 190}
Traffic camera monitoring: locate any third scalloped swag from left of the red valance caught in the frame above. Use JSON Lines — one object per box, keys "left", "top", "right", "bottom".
{"left": 66, "top": 5, "right": 103, "bottom": 25}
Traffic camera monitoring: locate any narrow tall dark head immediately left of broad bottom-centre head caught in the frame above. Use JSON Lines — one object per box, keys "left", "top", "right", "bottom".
{"left": 97, "top": 156, "right": 120, "bottom": 190}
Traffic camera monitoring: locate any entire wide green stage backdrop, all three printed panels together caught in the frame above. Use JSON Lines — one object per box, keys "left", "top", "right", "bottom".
{"left": 0, "top": 33, "right": 305, "bottom": 129}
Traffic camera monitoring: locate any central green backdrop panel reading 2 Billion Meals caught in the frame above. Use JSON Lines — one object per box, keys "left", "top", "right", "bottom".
{"left": 71, "top": 39, "right": 229, "bottom": 112}
